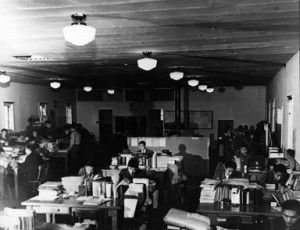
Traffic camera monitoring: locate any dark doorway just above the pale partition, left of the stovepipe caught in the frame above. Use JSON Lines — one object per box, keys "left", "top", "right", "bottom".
{"left": 147, "top": 109, "right": 163, "bottom": 137}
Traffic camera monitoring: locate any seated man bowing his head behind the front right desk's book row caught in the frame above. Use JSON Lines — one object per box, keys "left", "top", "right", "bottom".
{"left": 214, "top": 160, "right": 242, "bottom": 180}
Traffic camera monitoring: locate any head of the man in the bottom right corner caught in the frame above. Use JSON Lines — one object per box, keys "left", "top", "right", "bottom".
{"left": 282, "top": 200, "right": 300, "bottom": 227}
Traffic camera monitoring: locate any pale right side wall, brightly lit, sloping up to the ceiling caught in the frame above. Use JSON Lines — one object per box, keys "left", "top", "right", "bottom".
{"left": 267, "top": 51, "right": 300, "bottom": 162}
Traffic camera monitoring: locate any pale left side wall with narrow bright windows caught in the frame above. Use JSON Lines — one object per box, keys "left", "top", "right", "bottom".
{"left": 0, "top": 82, "right": 76, "bottom": 131}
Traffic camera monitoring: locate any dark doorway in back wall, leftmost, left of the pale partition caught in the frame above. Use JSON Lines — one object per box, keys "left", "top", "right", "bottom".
{"left": 98, "top": 109, "right": 113, "bottom": 144}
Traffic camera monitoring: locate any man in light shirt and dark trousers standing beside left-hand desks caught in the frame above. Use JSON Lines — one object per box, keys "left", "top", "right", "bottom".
{"left": 69, "top": 124, "right": 81, "bottom": 175}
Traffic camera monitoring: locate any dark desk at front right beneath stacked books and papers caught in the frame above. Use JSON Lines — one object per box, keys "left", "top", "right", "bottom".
{"left": 196, "top": 203, "right": 281, "bottom": 224}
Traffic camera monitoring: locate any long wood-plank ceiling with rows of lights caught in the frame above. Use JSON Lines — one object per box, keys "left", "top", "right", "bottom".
{"left": 0, "top": 0, "right": 299, "bottom": 88}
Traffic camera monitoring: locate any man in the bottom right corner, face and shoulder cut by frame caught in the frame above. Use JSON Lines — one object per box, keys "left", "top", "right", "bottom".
{"left": 272, "top": 200, "right": 300, "bottom": 230}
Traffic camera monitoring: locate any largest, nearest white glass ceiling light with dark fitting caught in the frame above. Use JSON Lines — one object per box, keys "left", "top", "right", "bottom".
{"left": 63, "top": 14, "right": 96, "bottom": 46}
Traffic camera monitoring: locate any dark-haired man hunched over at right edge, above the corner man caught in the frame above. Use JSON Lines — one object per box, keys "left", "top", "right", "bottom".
{"left": 258, "top": 164, "right": 288, "bottom": 188}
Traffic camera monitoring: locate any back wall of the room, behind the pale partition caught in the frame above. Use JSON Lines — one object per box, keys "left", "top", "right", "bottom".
{"left": 77, "top": 86, "right": 266, "bottom": 136}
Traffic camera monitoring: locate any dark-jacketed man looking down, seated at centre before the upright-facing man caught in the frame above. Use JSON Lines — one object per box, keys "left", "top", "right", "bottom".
{"left": 119, "top": 158, "right": 147, "bottom": 184}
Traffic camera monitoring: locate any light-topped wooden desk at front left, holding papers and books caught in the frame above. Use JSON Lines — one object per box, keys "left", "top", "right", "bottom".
{"left": 21, "top": 197, "right": 123, "bottom": 230}
